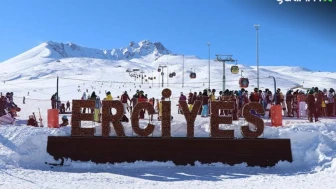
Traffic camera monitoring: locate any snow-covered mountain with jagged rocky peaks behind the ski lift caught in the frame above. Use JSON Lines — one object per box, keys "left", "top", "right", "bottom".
{"left": 0, "top": 40, "right": 336, "bottom": 93}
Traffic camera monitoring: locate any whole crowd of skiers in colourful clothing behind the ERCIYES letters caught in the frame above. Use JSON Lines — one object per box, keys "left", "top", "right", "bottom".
{"left": 23, "top": 87, "right": 336, "bottom": 126}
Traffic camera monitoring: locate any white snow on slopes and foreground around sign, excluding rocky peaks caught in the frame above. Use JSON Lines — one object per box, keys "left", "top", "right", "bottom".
{"left": 0, "top": 41, "right": 336, "bottom": 189}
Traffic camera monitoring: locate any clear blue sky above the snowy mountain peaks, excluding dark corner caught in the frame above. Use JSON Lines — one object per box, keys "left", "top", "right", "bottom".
{"left": 0, "top": 0, "right": 336, "bottom": 72}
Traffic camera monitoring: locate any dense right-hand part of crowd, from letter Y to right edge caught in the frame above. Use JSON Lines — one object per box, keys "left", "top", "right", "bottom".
{"left": 178, "top": 87, "right": 336, "bottom": 122}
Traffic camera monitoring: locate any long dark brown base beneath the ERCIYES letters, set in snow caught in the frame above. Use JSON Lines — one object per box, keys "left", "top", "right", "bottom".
{"left": 47, "top": 136, "right": 292, "bottom": 167}
